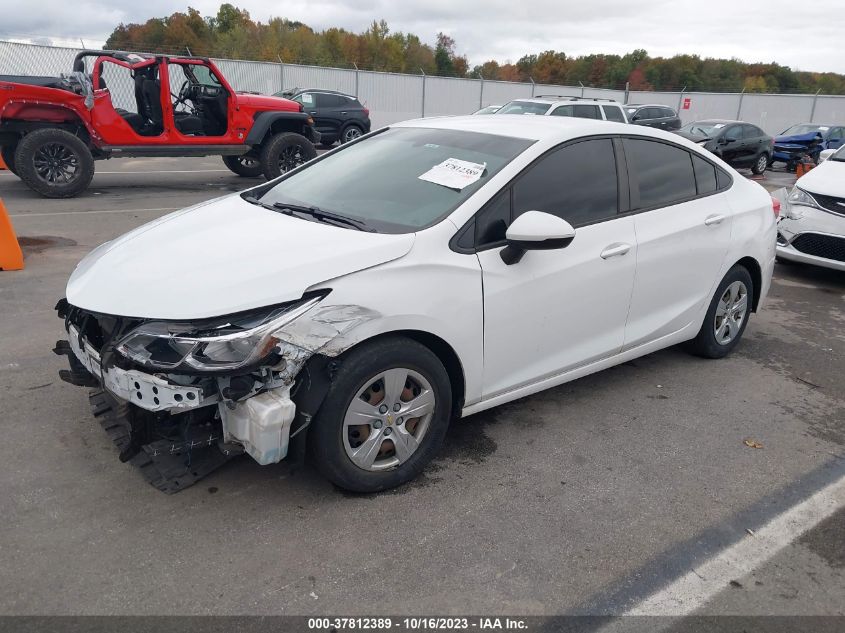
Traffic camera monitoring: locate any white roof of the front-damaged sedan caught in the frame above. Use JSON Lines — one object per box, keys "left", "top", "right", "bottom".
{"left": 390, "top": 114, "right": 685, "bottom": 144}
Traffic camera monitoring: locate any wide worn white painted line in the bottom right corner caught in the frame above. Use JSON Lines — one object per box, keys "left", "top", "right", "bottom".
{"left": 611, "top": 476, "right": 845, "bottom": 616}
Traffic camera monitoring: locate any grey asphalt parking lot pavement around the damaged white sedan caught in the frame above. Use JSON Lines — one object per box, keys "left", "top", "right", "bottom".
{"left": 0, "top": 158, "right": 845, "bottom": 615}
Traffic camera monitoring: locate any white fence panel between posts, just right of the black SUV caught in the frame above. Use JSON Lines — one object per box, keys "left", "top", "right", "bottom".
{"left": 358, "top": 71, "right": 423, "bottom": 130}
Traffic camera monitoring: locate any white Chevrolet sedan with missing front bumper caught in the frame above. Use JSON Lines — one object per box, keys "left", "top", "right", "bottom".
{"left": 56, "top": 115, "right": 775, "bottom": 491}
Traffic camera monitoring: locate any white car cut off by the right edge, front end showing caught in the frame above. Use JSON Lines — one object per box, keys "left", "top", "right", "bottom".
{"left": 777, "top": 146, "right": 845, "bottom": 270}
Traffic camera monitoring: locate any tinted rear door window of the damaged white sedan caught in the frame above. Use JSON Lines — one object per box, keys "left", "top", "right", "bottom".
{"left": 624, "top": 138, "right": 697, "bottom": 209}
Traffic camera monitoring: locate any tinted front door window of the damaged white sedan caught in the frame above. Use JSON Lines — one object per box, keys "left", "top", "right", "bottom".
{"left": 512, "top": 139, "right": 619, "bottom": 226}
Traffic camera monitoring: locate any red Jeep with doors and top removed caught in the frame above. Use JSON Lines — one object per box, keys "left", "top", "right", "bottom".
{"left": 0, "top": 51, "right": 320, "bottom": 198}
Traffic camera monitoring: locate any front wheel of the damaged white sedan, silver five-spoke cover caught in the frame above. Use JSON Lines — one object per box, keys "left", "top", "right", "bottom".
{"left": 308, "top": 337, "right": 452, "bottom": 492}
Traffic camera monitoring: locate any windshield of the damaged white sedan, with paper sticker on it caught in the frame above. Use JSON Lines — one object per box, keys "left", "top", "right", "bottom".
{"left": 246, "top": 128, "right": 534, "bottom": 233}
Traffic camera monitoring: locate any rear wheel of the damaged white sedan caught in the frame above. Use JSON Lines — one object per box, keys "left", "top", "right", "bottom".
{"left": 689, "top": 265, "right": 755, "bottom": 358}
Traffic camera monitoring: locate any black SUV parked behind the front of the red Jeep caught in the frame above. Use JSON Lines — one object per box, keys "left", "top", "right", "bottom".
{"left": 275, "top": 89, "right": 370, "bottom": 147}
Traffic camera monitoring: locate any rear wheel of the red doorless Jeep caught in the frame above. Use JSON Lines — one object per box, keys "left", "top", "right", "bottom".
{"left": 15, "top": 128, "right": 94, "bottom": 198}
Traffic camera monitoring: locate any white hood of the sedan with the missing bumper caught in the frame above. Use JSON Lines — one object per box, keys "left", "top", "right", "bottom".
{"left": 67, "top": 194, "right": 414, "bottom": 320}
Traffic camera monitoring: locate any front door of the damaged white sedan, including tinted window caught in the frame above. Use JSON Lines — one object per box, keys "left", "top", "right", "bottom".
{"left": 476, "top": 138, "right": 636, "bottom": 398}
